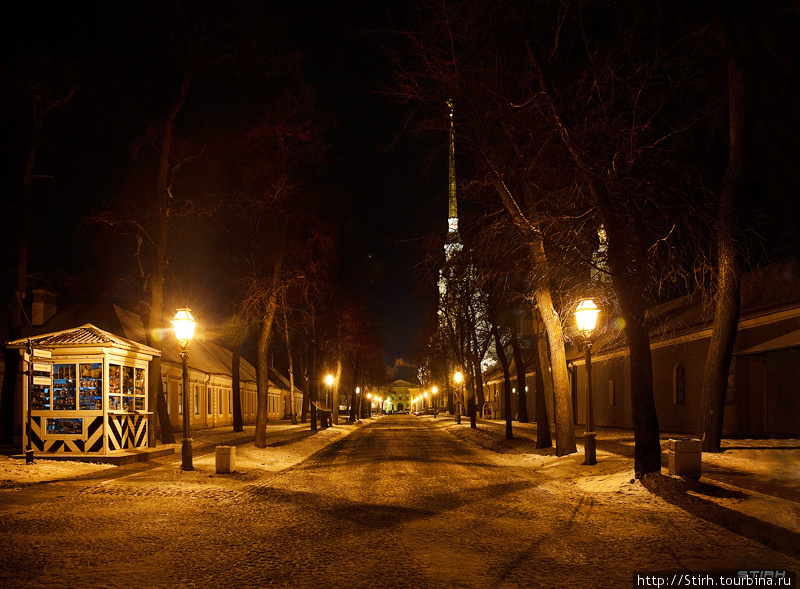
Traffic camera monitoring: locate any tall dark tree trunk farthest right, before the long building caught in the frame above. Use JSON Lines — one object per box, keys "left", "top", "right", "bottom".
{"left": 698, "top": 17, "right": 745, "bottom": 452}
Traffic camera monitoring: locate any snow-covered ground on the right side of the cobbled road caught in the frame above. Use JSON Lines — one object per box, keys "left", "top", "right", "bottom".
{"left": 434, "top": 419, "right": 800, "bottom": 533}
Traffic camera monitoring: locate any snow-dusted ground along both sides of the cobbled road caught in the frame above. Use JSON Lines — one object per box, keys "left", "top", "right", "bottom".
{"left": 0, "top": 416, "right": 800, "bottom": 533}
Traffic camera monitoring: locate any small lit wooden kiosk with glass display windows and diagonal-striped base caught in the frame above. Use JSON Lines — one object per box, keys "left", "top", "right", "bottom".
{"left": 8, "top": 324, "right": 161, "bottom": 455}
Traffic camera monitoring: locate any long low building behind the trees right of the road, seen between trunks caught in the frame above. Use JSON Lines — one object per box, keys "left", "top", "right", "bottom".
{"left": 485, "top": 263, "right": 800, "bottom": 436}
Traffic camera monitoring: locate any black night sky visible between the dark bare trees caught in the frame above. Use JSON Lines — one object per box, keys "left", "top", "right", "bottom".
{"left": 6, "top": 2, "right": 800, "bottom": 372}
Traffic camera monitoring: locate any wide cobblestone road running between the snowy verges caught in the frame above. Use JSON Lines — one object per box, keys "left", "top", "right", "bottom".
{"left": 0, "top": 416, "right": 800, "bottom": 589}
